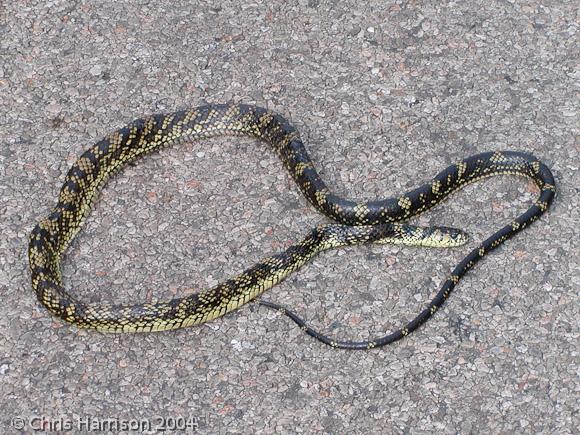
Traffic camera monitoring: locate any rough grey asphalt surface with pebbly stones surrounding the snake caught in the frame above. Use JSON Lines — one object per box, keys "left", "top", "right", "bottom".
{"left": 0, "top": 0, "right": 580, "bottom": 434}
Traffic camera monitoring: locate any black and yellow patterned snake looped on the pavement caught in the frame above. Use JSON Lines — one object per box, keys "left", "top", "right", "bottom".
{"left": 28, "top": 103, "right": 556, "bottom": 349}
